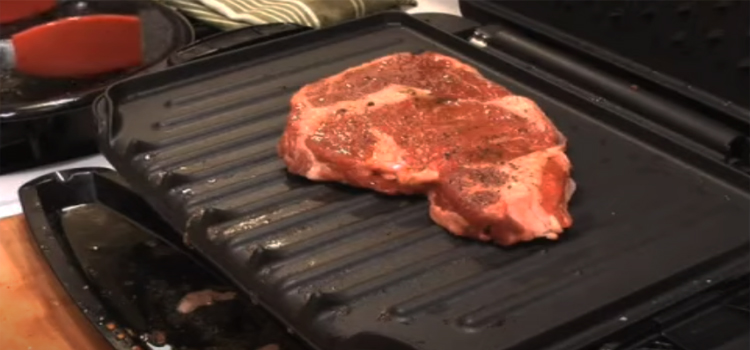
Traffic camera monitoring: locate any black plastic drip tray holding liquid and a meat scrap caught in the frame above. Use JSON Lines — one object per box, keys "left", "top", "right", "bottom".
{"left": 21, "top": 169, "right": 308, "bottom": 350}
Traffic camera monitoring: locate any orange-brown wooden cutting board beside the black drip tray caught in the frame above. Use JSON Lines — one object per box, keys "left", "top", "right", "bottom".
{"left": 0, "top": 215, "right": 112, "bottom": 350}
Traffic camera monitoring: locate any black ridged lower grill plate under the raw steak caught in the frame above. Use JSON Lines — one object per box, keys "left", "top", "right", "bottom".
{"left": 104, "top": 12, "right": 750, "bottom": 350}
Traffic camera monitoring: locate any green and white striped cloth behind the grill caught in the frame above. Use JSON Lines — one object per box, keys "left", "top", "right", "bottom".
{"left": 156, "top": 0, "right": 417, "bottom": 30}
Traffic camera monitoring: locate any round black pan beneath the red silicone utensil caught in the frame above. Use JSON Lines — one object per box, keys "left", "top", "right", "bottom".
{"left": 0, "top": 0, "right": 194, "bottom": 174}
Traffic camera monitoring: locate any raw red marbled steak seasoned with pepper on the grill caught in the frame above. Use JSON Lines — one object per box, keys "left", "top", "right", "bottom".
{"left": 279, "top": 52, "right": 575, "bottom": 245}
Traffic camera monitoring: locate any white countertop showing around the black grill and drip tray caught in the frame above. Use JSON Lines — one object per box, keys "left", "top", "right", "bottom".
{"left": 0, "top": 0, "right": 461, "bottom": 218}
